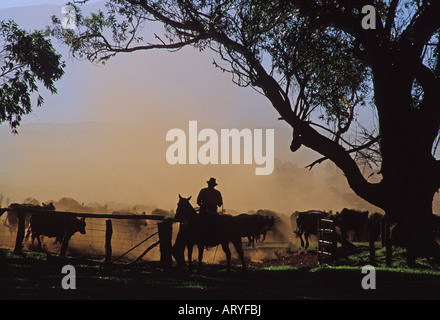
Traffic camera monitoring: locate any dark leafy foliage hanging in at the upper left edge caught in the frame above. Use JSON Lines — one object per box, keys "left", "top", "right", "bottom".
{"left": 0, "top": 21, "right": 64, "bottom": 133}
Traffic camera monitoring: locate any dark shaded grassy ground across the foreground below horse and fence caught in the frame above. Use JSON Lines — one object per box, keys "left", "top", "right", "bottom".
{"left": 0, "top": 245, "right": 440, "bottom": 300}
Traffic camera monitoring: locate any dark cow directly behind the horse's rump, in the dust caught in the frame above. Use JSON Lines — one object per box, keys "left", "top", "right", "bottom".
{"left": 236, "top": 213, "right": 275, "bottom": 246}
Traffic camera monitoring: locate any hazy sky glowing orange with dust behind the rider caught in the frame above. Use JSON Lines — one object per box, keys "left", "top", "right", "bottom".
{"left": 0, "top": 1, "right": 398, "bottom": 214}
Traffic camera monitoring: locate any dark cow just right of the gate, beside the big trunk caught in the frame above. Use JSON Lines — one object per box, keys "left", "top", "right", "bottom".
{"left": 336, "top": 208, "right": 381, "bottom": 243}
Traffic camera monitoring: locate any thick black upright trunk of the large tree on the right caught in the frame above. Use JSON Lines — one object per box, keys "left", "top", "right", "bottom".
{"left": 373, "top": 53, "right": 440, "bottom": 265}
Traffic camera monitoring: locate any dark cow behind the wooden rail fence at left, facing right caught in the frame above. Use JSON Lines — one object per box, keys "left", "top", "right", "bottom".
{"left": 26, "top": 211, "right": 86, "bottom": 257}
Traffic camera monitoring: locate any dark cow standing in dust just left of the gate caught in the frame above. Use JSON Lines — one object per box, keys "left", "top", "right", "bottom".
{"left": 290, "top": 210, "right": 328, "bottom": 249}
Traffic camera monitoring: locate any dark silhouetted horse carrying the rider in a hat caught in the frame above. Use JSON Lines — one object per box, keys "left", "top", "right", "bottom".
{"left": 173, "top": 194, "right": 246, "bottom": 272}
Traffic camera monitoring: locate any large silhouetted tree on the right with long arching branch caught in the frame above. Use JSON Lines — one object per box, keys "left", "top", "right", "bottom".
{"left": 52, "top": 0, "right": 440, "bottom": 263}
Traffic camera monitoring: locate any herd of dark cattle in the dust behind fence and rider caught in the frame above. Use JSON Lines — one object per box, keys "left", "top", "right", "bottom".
{"left": 0, "top": 203, "right": 380, "bottom": 264}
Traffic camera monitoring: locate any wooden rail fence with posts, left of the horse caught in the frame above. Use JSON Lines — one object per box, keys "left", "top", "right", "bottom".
{"left": 0, "top": 207, "right": 173, "bottom": 267}
